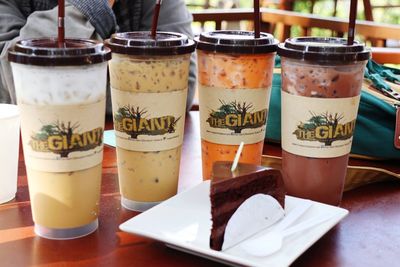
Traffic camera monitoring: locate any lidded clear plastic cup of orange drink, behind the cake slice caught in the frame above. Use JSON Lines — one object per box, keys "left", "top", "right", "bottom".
{"left": 196, "top": 31, "right": 278, "bottom": 180}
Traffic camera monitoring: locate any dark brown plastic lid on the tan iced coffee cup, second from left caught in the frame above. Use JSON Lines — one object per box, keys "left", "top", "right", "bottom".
{"left": 105, "top": 32, "right": 195, "bottom": 56}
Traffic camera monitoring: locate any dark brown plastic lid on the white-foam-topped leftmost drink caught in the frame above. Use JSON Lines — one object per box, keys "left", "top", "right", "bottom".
{"left": 8, "top": 38, "right": 111, "bottom": 66}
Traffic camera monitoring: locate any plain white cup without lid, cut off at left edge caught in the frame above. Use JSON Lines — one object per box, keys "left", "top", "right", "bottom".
{"left": 0, "top": 104, "right": 19, "bottom": 204}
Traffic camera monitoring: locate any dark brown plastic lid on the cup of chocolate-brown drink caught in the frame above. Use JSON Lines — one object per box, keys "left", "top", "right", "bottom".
{"left": 278, "top": 37, "right": 370, "bottom": 63}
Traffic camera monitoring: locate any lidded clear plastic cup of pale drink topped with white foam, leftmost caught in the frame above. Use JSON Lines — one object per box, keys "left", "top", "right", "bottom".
{"left": 9, "top": 39, "right": 111, "bottom": 239}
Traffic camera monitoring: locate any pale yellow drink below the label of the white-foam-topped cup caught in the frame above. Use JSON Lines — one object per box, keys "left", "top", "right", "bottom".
{"left": 27, "top": 164, "right": 101, "bottom": 228}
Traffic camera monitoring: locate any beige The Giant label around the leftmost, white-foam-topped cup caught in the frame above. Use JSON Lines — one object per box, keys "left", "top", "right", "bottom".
{"left": 19, "top": 99, "right": 105, "bottom": 172}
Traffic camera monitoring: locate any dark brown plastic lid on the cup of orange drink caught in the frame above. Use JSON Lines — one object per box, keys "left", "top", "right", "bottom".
{"left": 195, "top": 31, "right": 279, "bottom": 54}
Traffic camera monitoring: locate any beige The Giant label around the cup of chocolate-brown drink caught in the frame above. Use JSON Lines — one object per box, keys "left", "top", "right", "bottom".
{"left": 282, "top": 91, "right": 360, "bottom": 158}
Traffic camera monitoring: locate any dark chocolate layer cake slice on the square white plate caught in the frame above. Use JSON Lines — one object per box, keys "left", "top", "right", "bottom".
{"left": 210, "top": 161, "right": 286, "bottom": 250}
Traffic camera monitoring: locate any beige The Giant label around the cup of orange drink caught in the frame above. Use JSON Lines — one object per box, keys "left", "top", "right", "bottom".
{"left": 199, "top": 85, "right": 271, "bottom": 145}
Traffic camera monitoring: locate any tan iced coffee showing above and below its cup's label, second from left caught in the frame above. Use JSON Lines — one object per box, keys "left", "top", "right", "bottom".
{"left": 109, "top": 54, "right": 189, "bottom": 202}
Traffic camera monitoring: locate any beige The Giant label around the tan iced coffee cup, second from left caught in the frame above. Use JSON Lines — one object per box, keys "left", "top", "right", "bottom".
{"left": 111, "top": 88, "right": 187, "bottom": 151}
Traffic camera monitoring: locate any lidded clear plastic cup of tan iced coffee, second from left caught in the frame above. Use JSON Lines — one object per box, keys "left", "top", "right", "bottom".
{"left": 106, "top": 32, "right": 194, "bottom": 211}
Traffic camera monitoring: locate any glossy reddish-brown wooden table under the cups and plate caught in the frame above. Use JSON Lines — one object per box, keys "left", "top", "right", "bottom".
{"left": 0, "top": 111, "right": 400, "bottom": 267}
